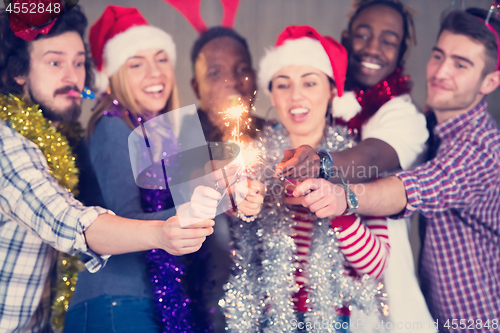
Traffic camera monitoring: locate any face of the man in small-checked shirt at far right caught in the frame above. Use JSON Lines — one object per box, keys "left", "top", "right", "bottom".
{"left": 427, "top": 30, "right": 486, "bottom": 118}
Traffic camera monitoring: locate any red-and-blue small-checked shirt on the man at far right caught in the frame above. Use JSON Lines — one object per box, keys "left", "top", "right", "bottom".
{"left": 396, "top": 100, "right": 500, "bottom": 332}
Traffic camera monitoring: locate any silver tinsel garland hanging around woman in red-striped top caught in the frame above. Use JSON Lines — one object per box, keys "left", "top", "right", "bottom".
{"left": 225, "top": 124, "right": 383, "bottom": 333}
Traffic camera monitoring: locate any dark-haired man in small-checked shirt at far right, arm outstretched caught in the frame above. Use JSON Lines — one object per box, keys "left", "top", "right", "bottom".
{"left": 294, "top": 9, "right": 500, "bottom": 332}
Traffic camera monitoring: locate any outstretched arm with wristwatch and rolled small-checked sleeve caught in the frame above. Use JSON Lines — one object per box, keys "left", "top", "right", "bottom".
{"left": 294, "top": 135, "right": 500, "bottom": 216}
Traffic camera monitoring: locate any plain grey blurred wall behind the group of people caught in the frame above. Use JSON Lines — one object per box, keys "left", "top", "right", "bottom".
{"left": 66, "top": 0, "right": 500, "bottom": 126}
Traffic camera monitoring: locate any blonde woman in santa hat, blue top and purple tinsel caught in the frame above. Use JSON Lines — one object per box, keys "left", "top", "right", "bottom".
{"left": 65, "top": 6, "right": 220, "bottom": 333}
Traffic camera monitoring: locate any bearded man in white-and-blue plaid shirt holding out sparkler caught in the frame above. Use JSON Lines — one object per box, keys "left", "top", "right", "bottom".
{"left": 0, "top": 7, "right": 220, "bottom": 333}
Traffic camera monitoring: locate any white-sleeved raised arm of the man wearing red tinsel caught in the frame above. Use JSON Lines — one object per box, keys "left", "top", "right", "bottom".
{"left": 277, "top": 95, "right": 428, "bottom": 183}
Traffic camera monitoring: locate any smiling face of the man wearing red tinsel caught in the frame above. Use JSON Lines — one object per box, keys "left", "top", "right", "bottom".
{"left": 348, "top": 5, "right": 404, "bottom": 87}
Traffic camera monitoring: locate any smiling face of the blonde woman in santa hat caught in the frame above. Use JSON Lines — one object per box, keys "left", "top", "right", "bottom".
{"left": 124, "top": 49, "right": 174, "bottom": 117}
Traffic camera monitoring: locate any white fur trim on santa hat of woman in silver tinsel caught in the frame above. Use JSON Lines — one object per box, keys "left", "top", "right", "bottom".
{"left": 259, "top": 37, "right": 333, "bottom": 94}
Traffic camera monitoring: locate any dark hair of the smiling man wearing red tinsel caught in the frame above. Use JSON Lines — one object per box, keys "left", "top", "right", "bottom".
{"left": 348, "top": 0, "right": 417, "bottom": 65}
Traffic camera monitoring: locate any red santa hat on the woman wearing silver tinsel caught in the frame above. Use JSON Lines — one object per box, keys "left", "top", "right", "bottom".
{"left": 259, "top": 25, "right": 347, "bottom": 96}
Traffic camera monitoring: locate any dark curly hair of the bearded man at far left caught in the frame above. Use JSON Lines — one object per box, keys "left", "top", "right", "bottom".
{"left": 0, "top": 6, "right": 94, "bottom": 95}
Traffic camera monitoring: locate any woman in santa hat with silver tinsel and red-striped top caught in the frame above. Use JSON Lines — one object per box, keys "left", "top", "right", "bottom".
{"left": 221, "top": 26, "right": 390, "bottom": 332}
